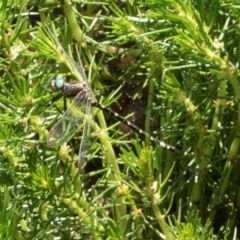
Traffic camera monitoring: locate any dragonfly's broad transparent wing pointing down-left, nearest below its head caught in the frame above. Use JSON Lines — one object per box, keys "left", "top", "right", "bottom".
{"left": 47, "top": 91, "right": 90, "bottom": 148}
